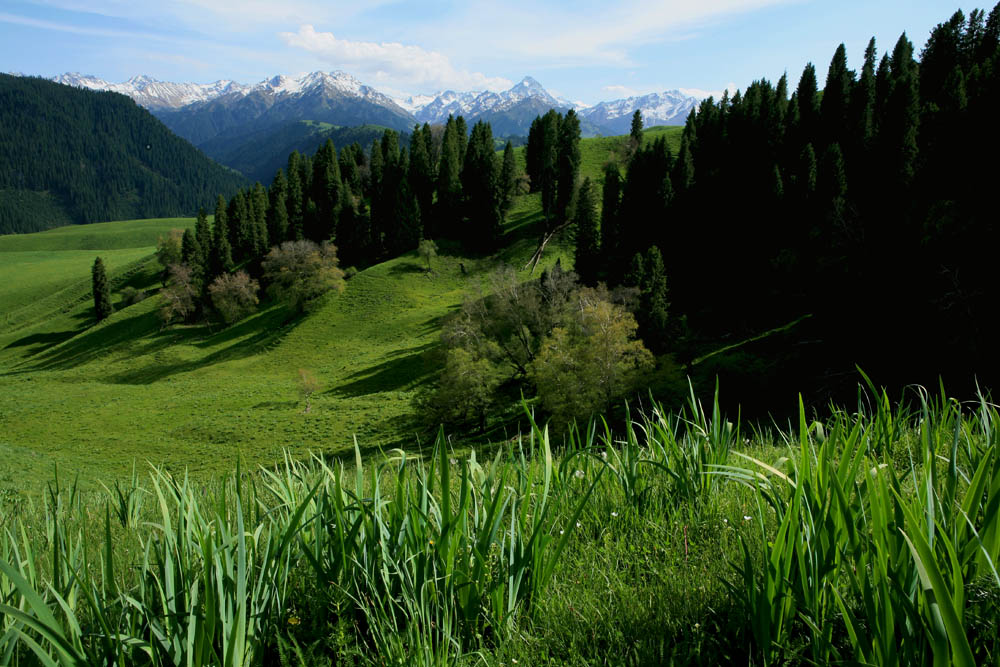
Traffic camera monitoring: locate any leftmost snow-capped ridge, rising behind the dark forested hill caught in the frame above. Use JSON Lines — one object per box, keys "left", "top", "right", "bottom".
{"left": 52, "top": 72, "right": 250, "bottom": 110}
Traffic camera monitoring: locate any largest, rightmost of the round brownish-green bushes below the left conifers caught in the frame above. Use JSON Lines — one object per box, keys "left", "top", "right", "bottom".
{"left": 263, "top": 240, "right": 345, "bottom": 313}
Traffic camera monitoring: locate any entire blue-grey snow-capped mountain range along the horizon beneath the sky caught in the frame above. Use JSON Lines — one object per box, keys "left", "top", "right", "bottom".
{"left": 52, "top": 71, "right": 699, "bottom": 181}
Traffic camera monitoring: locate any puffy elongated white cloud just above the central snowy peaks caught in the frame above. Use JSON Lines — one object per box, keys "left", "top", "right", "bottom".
{"left": 279, "top": 24, "right": 512, "bottom": 91}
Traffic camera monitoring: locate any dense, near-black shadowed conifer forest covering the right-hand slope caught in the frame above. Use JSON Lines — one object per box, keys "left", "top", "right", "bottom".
{"left": 576, "top": 5, "right": 1000, "bottom": 400}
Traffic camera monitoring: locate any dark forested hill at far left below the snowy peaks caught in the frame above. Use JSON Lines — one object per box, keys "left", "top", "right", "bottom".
{"left": 0, "top": 74, "right": 246, "bottom": 234}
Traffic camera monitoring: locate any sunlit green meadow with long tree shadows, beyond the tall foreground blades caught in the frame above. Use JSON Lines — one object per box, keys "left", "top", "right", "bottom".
{"left": 0, "top": 196, "right": 568, "bottom": 490}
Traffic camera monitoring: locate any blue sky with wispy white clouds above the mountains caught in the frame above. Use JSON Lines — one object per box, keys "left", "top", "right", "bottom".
{"left": 0, "top": 0, "right": 968, "bottom": 104}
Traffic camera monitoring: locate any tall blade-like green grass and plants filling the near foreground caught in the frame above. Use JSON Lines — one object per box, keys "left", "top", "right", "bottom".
{"left": 0, "top": 384, "right": 1000, "bottom": 665}
